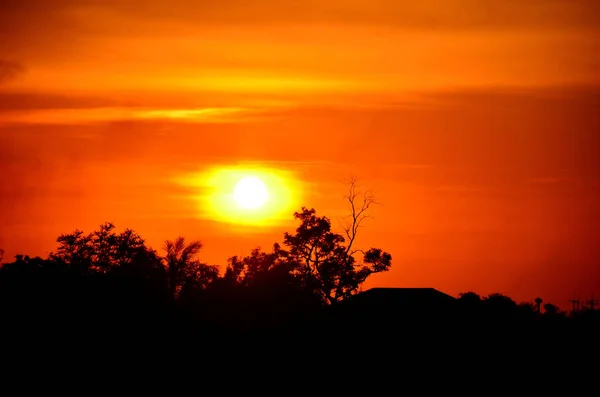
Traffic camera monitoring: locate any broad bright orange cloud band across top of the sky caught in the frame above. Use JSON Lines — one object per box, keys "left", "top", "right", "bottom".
{"left": 0, "top": 0, "right": 600, "bottom": 100}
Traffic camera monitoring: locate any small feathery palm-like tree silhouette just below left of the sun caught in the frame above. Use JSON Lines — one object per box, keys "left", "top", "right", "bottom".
{"left": 164, "top": 236, "right": 219, "bottom": 298}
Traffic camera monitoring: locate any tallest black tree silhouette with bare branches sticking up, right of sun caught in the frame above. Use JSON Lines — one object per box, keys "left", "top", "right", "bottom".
{"left": 218, "top": 178, "right": 392, "bottom": 304}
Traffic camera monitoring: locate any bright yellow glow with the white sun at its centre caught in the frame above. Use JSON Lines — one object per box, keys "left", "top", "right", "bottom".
{"left": 177, "top": 166, "right": 301, "bottom": 227}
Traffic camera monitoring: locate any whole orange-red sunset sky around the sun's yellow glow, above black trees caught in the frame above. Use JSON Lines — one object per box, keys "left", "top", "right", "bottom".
{"left": 0, "top": 0, "right": 600, "bottom": 309}
